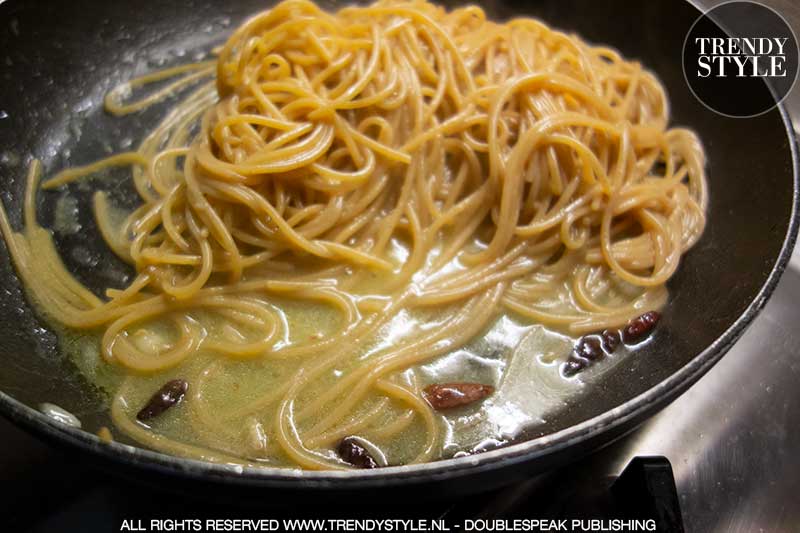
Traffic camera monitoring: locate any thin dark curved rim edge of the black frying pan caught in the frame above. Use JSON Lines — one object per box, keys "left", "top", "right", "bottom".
{"left": 0, "top": 3, "right": 800, "bottom": 490}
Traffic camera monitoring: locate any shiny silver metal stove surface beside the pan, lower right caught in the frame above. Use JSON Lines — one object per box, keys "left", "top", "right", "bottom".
{"left": 472, "top": 262, "right": 800, "bottom": 533}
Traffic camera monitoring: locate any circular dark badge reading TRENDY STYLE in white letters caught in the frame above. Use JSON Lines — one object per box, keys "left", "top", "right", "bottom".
{"left": 683, "top": 1, "right": 798, "bottom": 118}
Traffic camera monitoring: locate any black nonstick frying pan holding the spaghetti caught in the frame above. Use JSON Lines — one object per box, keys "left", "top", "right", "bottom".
{"left": 0, "top": 0, "right": 798, "bottom": 496}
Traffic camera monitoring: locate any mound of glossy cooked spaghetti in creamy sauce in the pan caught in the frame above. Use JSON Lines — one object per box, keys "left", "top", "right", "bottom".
{"left": 0, "top": 0, "right": 706, "bottom": 469}
